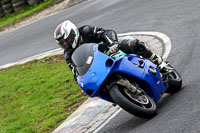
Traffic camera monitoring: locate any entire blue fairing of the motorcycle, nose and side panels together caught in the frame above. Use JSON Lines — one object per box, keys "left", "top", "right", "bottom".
{"left": 77, "top": 45, "right": 166, "bottom": 101}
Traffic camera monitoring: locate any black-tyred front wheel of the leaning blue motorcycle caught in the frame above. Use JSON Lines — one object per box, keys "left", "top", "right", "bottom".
{"left": 110, "top": 85, "right": 157, "bottom": 119}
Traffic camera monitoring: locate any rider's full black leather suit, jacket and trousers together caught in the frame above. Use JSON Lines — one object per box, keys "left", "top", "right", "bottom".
{"left": 64, "top": 25, "right": 153, "bottom": 80}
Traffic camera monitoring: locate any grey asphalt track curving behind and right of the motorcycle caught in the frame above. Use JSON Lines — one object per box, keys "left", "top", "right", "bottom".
{"left": 0, "top": 0, "right": 200, "bottom": 133}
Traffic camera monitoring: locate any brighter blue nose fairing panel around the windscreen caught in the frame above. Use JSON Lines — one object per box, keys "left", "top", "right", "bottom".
{"left": 77, "top": 45, "right": 114, "bottom": 97}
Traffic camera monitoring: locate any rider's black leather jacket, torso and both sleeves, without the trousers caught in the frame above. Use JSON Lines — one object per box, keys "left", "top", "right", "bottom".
{"left": 64, "top": 25, "right": 118, "bottom": 73}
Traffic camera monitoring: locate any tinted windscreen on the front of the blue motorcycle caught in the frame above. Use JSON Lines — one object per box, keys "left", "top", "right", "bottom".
{"left": 72, "top": 43, "right": 94, "bottom": 76}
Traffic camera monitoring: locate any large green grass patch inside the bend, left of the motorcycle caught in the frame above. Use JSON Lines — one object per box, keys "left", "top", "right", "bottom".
{"left": 0, "top": 56, "right": 88, "bottom": 133}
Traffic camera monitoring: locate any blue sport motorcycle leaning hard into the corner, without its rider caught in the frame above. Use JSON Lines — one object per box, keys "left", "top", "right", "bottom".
{"left": 72, "top": 43, "right": 182, "bottom": 118}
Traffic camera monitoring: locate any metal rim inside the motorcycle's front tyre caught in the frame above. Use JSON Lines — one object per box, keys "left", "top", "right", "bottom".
{"left": 122, "top": 87, "right": 153, "bottom": 108}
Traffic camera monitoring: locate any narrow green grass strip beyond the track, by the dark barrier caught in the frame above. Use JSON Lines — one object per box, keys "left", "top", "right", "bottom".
{"left": 0, "top": 0, "right": 54, "bottom": 29}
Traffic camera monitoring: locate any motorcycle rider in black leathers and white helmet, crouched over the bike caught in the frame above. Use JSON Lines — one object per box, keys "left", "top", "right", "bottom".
{"left": 54, "top": 20, "right": 163, "bottom": 80}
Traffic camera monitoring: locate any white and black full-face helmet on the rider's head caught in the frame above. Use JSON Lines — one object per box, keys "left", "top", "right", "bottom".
{"left": 54, "top": 20, "right": 79, "bottom": 49}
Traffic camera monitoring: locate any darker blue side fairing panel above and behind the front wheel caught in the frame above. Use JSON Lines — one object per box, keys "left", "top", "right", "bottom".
{"left": 111, "top": 54, "right": 165, "bottom": 101}
